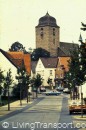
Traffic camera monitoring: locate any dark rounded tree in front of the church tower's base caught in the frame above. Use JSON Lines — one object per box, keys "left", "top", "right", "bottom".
{"left": 31, "top": 48, "right": 50, "bottom": 61}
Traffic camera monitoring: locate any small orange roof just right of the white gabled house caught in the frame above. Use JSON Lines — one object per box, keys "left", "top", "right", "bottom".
{"left": 58, "top": 57, "right": 70, "bottom": 71}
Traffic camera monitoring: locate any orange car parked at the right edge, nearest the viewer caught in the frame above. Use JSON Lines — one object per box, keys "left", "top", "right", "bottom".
{"left": 69, "top": 100, "right": 86, "bottom": 115}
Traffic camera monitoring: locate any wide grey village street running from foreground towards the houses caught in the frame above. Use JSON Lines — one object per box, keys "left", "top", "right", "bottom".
{"left": 0, "top": 94, "right": 85, "bottom": 130}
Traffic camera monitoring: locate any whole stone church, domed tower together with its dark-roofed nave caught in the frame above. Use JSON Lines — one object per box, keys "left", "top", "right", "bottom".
{"left": 35, "top": 12, "right": 78, "bottom": 57}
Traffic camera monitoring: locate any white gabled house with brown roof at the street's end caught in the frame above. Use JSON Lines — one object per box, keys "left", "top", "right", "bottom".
{"left": 35, "top": 58, "right": 58, "bottom": 86}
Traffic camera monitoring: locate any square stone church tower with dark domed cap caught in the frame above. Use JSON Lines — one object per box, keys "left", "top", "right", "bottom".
{"left": 35, "top": 12, "right": 59, "bottom": 57}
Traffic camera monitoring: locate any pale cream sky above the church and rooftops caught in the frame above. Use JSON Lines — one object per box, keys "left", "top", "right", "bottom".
{"left": 0, "top": 0, "right": 86, "bottom": 51}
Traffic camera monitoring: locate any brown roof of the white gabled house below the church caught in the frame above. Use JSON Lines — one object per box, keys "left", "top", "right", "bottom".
{"left": 40, "top": 58, "right": 58, "bottom": 68}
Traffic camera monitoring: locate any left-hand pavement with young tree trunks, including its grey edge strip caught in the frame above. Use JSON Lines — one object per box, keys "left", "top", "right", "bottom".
{"left": 0, "top": 94, "right": 43, "bottom": 121}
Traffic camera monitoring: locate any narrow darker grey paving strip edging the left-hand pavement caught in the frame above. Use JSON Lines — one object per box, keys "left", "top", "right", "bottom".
{"left": 0, "top": 97, "right": 44, "bottom": 121}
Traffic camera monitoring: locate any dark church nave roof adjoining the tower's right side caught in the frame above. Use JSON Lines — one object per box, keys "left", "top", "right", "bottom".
{"left": 58, "top": 42, "right": 78, "bottom": 56}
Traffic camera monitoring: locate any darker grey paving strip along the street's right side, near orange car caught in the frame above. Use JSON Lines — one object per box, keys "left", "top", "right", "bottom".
{"left": 58, "top": 97, "right": 78, "bottom": 130}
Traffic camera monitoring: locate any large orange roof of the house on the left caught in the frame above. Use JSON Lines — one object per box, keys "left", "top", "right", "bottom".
{"left": 0, "top": 49, "right": 31, "bottom": 74}
